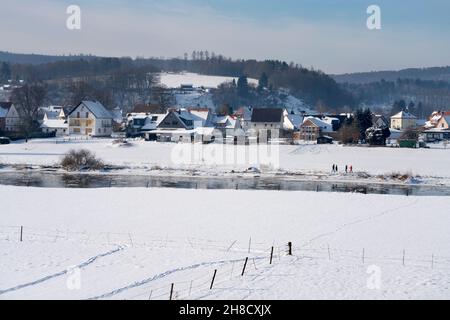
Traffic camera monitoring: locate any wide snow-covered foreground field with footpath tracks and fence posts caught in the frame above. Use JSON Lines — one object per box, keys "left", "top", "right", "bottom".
{"left": 0, "top": 186, "right": 450, "bottom": 300}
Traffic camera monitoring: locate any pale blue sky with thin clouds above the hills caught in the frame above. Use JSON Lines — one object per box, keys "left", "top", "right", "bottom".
{"left": 0, "top": 0, "right": 450, "bottom": 73}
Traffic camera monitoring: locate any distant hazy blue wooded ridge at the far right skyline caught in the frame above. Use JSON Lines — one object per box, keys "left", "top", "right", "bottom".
{"left": 332, "top": 66, "right": 450, "bottom": 84}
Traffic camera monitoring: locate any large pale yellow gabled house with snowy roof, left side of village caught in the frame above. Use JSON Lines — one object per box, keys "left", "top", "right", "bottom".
{"left": 67, "top": 101, "right": 113, "bottom": 137}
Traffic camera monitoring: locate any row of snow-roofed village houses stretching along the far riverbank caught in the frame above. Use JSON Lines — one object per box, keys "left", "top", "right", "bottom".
{"left": 0, "top": 81, "right": 450, "bottom": 148}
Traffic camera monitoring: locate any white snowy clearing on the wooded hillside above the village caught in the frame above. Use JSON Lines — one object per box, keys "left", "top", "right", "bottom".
{"left": 159, "top": 72, "right": 258, "bottom": 89}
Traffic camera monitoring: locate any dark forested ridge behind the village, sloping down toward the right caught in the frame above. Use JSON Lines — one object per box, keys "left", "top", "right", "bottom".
{"left": 0, "top": 53, "right": 356, "bottom": 110}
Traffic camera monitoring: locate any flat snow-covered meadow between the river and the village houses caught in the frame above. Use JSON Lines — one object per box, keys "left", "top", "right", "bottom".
{"left": 0, "top": 139, "right": 450, "bottom": 184}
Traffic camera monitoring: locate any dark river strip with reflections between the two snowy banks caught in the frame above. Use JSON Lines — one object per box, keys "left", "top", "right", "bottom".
{"left": 0, "top": 172, "right": 450, "bottom": 196}
